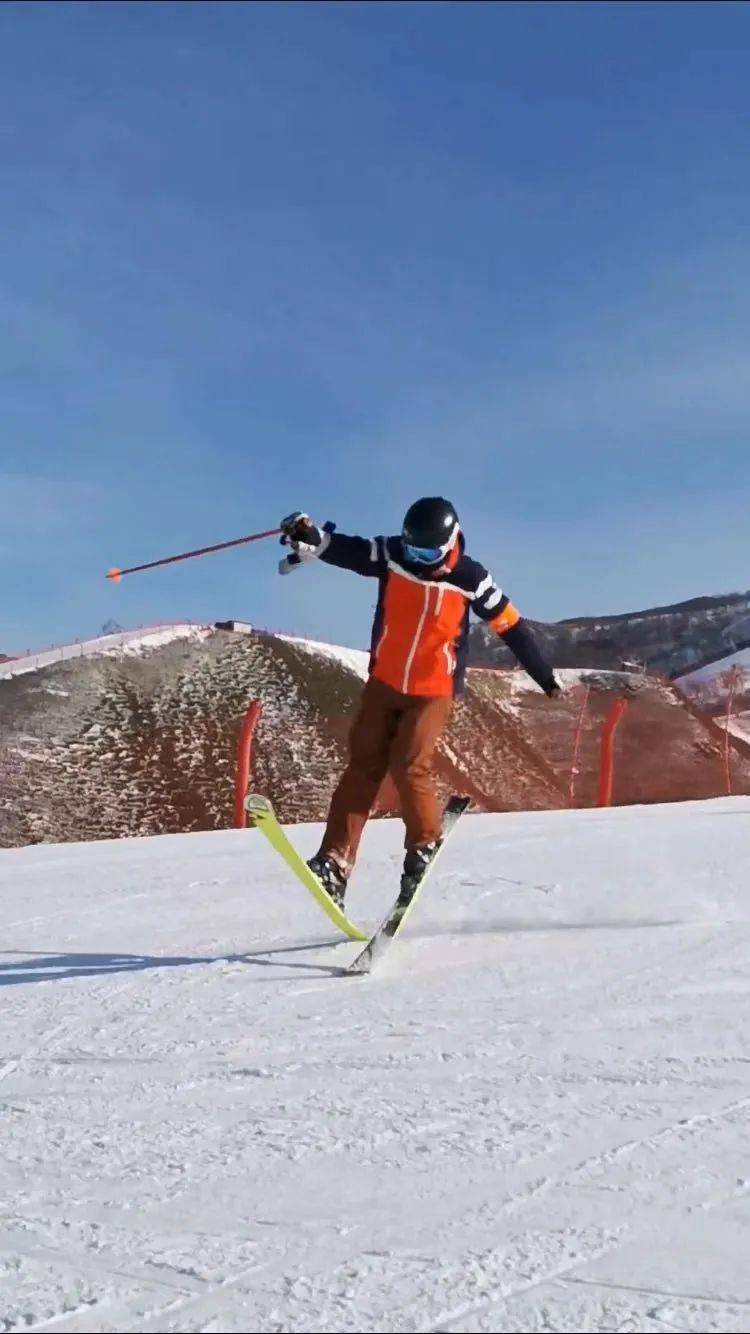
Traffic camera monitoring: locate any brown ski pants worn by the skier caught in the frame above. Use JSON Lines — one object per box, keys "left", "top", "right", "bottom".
{"left": 322, "top": 678, "right": 454, "bottom": 874}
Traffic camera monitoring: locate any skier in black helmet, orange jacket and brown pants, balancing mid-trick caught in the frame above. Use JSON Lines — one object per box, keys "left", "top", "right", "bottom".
{"left": 280, "top": 496, "right": 559, "bottom": 908}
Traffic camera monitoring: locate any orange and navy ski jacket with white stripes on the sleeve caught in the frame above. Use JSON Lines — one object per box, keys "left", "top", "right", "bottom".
{"left": 315, "top": 532, "right": 555, "bottom": 698}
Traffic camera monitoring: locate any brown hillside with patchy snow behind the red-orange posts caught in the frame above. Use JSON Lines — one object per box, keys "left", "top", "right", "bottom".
{"left": 0, "top": 630, "right": 750, "bottom": 847}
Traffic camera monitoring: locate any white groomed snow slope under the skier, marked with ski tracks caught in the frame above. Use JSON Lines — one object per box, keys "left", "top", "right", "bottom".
{"left": 0, "top": 798, "right": 750, "bottom": 1334}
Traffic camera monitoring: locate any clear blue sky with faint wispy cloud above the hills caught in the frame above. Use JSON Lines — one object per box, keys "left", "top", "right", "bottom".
{"left": 0, "top": 3, "right": 750, "bottom": 651}
